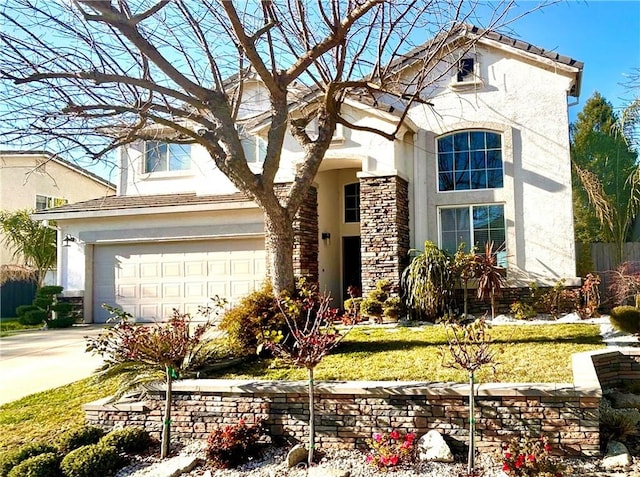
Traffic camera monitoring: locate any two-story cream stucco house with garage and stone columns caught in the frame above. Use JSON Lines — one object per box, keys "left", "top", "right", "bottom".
{"left": 38, "top": 28, "right": 582, "bottom": 321}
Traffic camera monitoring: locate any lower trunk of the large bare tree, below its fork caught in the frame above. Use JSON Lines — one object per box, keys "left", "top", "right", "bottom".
{"left": 265, "top": 209, "right": 295, "bottom": 295}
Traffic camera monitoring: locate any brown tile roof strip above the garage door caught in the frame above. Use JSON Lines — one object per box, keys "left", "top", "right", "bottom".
{"left": 34, "top": 193, "right": 249, "bottom": 216}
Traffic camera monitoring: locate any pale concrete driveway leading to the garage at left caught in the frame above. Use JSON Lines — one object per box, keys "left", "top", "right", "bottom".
{"left": 0, "top": 325, "right": 104, "bottom": 405}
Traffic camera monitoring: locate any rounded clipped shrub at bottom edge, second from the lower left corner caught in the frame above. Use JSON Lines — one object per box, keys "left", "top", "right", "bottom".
{"left": 60, "top": 444, "right": 123, "bottom": 477}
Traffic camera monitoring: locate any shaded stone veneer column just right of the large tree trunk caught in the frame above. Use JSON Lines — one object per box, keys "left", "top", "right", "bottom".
{"left": 267, "top": 184, "right": 318, "bottom": 283}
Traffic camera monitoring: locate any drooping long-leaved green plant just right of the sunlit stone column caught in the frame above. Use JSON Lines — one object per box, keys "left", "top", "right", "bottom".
{"left": 400, "top": 241, "right": 455, "bottom": 321}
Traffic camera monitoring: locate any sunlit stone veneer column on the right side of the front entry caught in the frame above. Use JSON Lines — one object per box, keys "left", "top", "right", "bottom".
{"left": 360, "top": 176, "right": 409, "bottom": 295}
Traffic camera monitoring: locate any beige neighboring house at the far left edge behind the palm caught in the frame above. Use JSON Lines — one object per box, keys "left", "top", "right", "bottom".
{"left": 0, "top": 150, "right": 115, "bottom": 316}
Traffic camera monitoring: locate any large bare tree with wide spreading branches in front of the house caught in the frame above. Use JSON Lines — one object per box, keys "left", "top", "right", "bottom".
{"left": 0, "top": 0, "right": 546, "bottom": 293}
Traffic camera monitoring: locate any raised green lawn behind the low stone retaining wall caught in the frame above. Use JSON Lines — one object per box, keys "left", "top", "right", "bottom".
{"left": 212, "top": 324, "right": 604, "bottom": 382}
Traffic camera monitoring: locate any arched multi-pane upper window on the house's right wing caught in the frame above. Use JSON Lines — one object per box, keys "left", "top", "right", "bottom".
{"left": 438, "top": 131, "right": 503, "bottom": 192}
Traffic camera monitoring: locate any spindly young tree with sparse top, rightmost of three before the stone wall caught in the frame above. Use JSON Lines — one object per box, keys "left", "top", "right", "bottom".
{"left": 442, "top": 318, "right": 495, "bottom": 476}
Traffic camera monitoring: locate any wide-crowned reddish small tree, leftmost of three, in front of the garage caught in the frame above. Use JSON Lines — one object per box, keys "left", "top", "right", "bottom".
{"left": 86, "top": 301, "right": 223, "bottom": 458}
